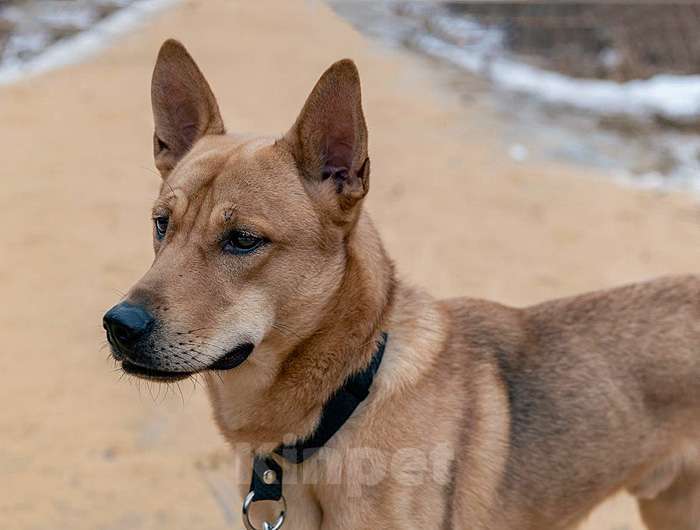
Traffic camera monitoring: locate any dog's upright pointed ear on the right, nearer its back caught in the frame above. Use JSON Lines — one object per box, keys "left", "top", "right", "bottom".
{"left": 285, "top": 59, "right": 369, "bottom": 211}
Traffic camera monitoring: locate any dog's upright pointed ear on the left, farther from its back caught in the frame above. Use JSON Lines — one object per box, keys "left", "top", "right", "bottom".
{"left": 151, "top": 39, "right": 225, "bottom": 178}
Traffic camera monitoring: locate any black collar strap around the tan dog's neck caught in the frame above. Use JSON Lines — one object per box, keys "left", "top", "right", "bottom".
{"left": 249, "top": 333, "right": 388, "bottom": 502}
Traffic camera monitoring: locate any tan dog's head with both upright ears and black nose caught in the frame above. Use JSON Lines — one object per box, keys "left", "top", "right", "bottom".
{"left": 104, "top": 41, "right": 369, "bottom": 381}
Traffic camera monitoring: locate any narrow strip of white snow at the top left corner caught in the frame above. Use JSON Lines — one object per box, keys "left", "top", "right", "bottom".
{"left": 0, "top": 0, "right": 179, "bottom": 85}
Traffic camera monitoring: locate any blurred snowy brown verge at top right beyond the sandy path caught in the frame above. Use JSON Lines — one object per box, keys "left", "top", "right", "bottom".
{"left": 331, "top": 1, "right": 700, "bottom": 191}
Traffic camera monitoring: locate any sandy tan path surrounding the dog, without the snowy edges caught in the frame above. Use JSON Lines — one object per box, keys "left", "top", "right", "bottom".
{"left": 0, "top": 0, "right": 700, "bottom": 530}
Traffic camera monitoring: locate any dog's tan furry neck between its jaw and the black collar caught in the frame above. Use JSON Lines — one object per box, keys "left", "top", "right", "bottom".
{"left": 208, "top": 208, "right": 395, "bottom": 451}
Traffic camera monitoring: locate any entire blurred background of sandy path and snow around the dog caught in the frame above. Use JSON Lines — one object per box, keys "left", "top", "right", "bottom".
{"left": 0, "top": 0, "right": 700, "bottom": 530}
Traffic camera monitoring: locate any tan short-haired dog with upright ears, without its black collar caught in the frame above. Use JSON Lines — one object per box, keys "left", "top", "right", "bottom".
{"left": 105, "top": 41, "right": 700, "bottom": 530}
